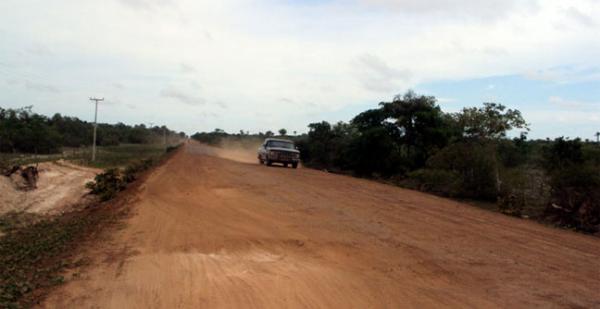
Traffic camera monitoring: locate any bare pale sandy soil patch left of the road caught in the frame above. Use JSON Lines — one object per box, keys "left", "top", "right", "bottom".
{"left": 0, "top": 161, "right": 100, "bottom": 214}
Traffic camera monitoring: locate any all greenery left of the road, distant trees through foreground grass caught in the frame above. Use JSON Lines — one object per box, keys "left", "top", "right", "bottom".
{"left": 0, "top": 108, "right": 185, "bottom": 308}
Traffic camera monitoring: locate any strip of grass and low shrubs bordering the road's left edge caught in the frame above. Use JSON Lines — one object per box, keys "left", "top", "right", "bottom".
{"left": 0, "top": 146, "right": 178, "bottom": 308}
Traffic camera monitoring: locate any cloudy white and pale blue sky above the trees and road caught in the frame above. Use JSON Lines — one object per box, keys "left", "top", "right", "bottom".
{"left": 0, "top": 0, "right": 600, "bottom": 139}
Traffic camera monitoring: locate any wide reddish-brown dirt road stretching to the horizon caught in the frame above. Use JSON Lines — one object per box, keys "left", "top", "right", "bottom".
{"left": 43, "top": 144, "right": 600, "bottom": 308}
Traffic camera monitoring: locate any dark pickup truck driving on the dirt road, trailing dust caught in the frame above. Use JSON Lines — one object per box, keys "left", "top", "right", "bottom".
{"left": 258, "top": 138, "right": 300, "bottom": 168}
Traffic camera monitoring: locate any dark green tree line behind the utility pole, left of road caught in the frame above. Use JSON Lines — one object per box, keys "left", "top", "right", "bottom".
{"left": 0, "top": 106, "right": 185, "bottom": 154}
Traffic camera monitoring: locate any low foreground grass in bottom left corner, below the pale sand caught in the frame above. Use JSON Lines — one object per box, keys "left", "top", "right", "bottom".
{"left": 0, "top": 209, "right": 111, "bottom": 308}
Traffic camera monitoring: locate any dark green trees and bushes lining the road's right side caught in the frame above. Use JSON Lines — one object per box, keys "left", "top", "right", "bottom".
{"left": 192, "top": 91, "right": 600, "bottom": 233}
